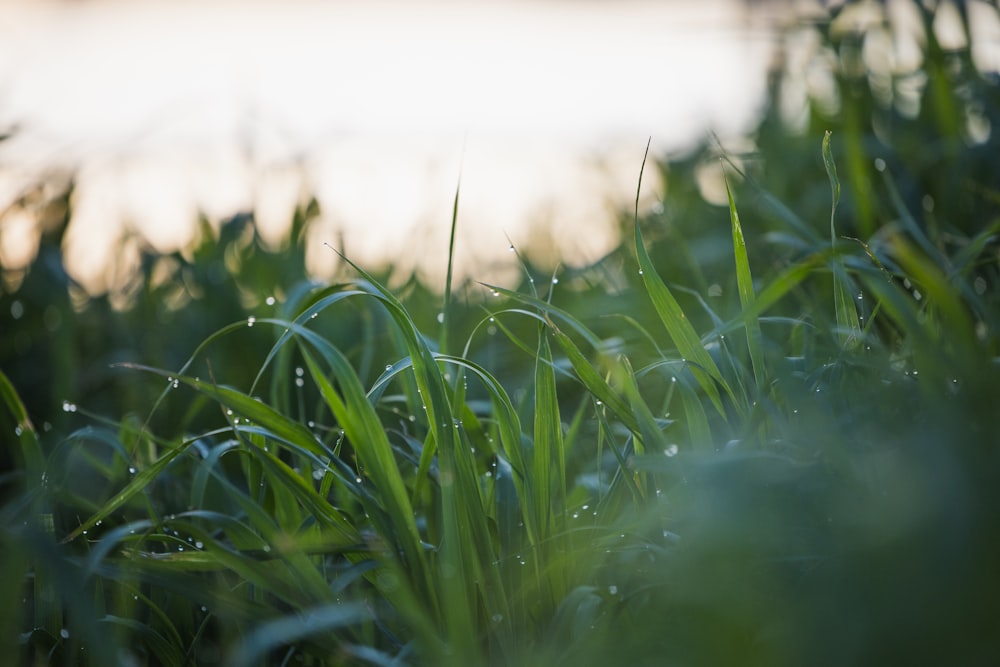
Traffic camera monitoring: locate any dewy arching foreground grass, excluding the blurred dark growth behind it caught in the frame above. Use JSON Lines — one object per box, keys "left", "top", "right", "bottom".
{"left": 2, "top": 128, "right": 998, "bottom": 665}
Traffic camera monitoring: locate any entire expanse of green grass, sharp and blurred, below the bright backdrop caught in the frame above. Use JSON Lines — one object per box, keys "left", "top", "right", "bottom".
{"left": 0, "top": 3, "right": 1000, "bottom": 665}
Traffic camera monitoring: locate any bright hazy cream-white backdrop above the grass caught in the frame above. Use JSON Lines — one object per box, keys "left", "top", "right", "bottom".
{"left": 0, "top": 0, "right": 787, "bottom": 292}
